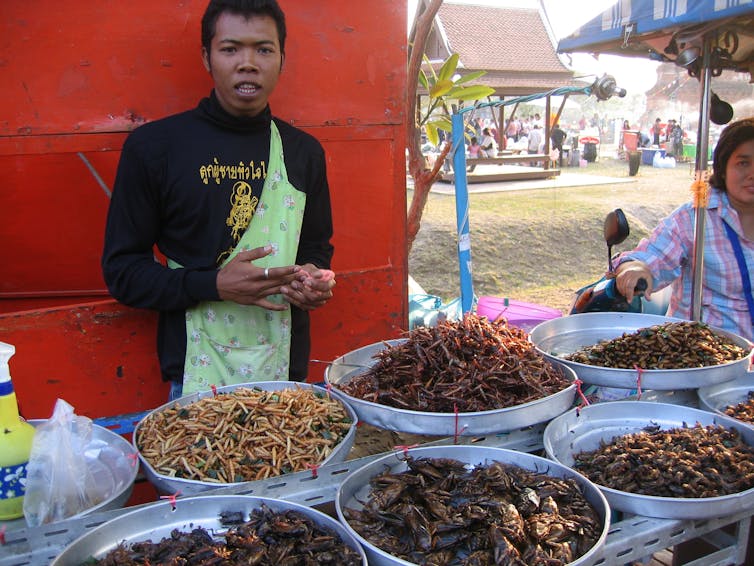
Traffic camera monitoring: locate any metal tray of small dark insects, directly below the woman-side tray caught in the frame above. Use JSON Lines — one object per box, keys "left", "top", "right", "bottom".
{"left": 543, "top": 401, "right": 754, "bottom": 519}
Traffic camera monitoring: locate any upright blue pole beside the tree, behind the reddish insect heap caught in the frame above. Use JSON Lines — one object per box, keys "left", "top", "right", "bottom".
{"left": 451, "top": 114, "right": 474, "bottom": 314}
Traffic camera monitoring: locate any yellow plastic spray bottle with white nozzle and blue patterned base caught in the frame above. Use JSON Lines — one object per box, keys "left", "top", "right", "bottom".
{"left": 0, "top": 342, "right": 34, "bottom": 520}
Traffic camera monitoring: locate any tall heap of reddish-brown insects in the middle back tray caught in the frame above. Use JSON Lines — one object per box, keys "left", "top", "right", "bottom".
{"left": 336, "top": 314, "right": 571, "bottom": 413}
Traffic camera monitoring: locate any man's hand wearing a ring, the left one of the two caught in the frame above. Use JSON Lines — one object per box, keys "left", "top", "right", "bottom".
{"left": 217, "top": 246, "right": 301, "bottom": 311}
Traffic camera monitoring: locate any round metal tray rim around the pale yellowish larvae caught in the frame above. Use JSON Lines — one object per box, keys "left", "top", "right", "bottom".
{"left": 133, "top": 381, "right": 359, "bottom": 496}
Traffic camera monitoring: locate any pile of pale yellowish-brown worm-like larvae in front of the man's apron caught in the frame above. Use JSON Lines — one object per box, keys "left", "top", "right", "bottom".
{"left": 136, "top": 387, "right": 353, "bottom": 483}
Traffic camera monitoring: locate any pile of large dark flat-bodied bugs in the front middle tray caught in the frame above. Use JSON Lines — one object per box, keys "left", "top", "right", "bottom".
{"left": 343, "top": 456, "right": 602, "bottom": 566}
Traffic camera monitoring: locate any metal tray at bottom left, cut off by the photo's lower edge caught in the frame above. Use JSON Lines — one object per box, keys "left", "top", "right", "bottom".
{"left": 51, "top": 495, "right": 367, "bottom": 566}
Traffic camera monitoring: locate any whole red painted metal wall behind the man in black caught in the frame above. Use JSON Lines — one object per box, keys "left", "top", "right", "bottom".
{"left": 0, "top": 0, "right": 407, "bottom": 418}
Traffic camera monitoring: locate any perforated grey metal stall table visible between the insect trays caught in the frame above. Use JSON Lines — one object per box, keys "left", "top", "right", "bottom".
{"left": 0, "top": 391, "right": 754, "bottom": 566}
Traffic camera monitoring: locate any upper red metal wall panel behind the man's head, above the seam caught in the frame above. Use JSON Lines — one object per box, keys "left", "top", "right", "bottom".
{"left": 0, "top": 0, "right": 407, "bottom": 135}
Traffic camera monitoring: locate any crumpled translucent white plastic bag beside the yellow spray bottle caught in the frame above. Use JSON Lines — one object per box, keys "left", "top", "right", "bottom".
{"left": 24, "top": 399, "right": 111, "bottom": 527}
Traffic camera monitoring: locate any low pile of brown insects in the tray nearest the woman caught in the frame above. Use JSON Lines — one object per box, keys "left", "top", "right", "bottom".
{"left": 565, "top": 321, "right": 749, "bottom": 369}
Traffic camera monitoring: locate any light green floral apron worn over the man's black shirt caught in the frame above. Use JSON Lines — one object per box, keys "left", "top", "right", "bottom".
{"left": 171, "top": 122, "right": 306, "bottom": 395}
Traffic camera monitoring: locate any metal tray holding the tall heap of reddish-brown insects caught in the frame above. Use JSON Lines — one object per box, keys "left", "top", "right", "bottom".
{"left": 325, "top": 339, "right": 576, "bottom": 436}
